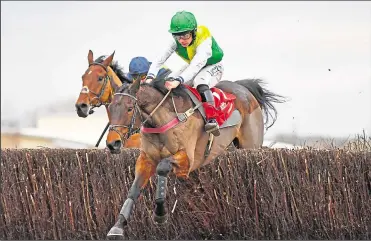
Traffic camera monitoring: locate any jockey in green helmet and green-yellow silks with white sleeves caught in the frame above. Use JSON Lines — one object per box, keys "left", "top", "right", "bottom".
{"left": 145, "top": 11, "right": 224, "bottom": 136}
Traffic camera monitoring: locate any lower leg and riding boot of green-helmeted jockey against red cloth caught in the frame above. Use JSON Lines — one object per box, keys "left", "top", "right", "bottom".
{"left": 197, "top": 84, "right": 220, "bottom": 136}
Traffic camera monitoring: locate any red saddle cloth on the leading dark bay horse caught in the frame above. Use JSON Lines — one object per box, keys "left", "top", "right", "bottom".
{"left": 183, "top": 84, "right": 236, "bottom": 126}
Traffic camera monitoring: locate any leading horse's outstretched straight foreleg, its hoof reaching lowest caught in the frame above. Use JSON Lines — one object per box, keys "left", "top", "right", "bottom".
{"left": 107, "top": 152, "right": 156, "bottom": 236}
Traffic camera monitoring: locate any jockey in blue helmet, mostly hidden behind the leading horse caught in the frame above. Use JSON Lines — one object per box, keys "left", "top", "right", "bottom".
{"left": 126, "top": 56, "right": 168, "bottom": 83}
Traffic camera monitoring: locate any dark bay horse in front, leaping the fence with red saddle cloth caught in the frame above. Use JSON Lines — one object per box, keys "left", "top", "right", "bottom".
{"left": 107, "top": 67, "right": 285, "bottom": 237}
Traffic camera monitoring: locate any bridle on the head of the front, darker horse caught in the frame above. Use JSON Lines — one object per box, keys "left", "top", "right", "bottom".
{"left": 109, "top": 92, "right": 143, "bottom": 145}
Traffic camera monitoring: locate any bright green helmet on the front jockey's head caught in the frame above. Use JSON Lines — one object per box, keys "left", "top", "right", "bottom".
{"left": 169, "top": 11, "right": 197, "bottom": 34}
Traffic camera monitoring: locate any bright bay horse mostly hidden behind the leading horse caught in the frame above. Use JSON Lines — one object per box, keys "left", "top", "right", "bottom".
{"left": 75, "top": 50, "right": 140, "bottom": 148}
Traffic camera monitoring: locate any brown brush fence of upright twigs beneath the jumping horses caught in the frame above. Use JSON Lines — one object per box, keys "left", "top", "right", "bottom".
{"left": 0, "top": 149, "right": 371, "bottom": 240}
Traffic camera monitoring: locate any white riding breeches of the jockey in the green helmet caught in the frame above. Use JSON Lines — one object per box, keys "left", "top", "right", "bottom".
{"left": 170, "top": 62, "right": 224, "bottom": 87}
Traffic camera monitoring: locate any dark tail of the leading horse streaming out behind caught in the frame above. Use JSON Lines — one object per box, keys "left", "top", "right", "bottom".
{"left": 235, "top": 79, "right": 287, "bottom": 129}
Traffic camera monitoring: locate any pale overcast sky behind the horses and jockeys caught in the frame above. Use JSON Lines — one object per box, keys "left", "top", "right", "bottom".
{"left": 1, "top": 1, "right": 371, "bottom": 136}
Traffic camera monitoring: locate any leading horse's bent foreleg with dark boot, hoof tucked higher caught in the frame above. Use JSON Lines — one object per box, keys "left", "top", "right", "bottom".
{"left": 153, "top": 158, "right": 172, "bottom": 223}
